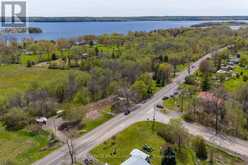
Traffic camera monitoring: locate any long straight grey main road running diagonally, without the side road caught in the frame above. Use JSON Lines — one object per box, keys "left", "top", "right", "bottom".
{"left": 34, "top": 48, "right": 240, "bottom": 165}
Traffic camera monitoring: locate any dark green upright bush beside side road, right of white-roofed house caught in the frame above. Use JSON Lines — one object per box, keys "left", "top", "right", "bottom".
{"left": 193, "top": 137, "right": 208, "bottom": 160}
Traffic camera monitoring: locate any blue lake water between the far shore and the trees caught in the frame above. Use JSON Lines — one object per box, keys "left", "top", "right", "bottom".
{"left": 1, "top": 21, "right": 244, "bottom": 40}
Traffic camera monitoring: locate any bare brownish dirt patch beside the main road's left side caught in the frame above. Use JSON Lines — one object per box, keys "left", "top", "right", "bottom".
{"left": 84, "top": 96, "right": 113, "bottom": 120}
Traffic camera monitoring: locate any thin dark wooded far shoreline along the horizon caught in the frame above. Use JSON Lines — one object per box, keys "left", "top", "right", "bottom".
{"left": 1, "top": 16, "right": 248, "bottom": 22}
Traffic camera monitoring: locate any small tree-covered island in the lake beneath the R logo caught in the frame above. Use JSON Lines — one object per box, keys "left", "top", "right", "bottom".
{"left": 0, "top": 27, "right": 42, "bottom": 34}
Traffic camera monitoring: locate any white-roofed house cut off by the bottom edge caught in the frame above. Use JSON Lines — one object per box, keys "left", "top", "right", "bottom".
{"left": 121, "top": 149, "right": 150, "bottom": 165}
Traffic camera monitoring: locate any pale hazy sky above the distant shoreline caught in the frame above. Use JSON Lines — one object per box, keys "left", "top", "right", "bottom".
{"left": 24, "top": 0, "right": 248, "bottom": 17}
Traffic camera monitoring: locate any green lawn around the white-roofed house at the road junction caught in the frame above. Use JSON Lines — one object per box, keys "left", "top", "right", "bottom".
{"left": 91, "top": 122, "right": 164, "bottom": 165}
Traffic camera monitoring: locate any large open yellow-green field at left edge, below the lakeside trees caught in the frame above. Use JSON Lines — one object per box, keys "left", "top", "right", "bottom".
{"left": 0, "top": 65, "right": 78, "bottom": 103}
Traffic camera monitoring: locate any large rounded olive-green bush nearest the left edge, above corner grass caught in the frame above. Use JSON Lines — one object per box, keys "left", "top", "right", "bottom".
{"left": 2, "top": 108, "right": 30, "bottom": 131}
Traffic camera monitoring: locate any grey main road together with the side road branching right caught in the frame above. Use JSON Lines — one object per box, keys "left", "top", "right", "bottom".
{"left": 34, "top": 48, "right": 248, "bottom": 165}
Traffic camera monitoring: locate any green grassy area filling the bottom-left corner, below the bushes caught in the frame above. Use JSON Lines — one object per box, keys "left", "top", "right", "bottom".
{"left": 0, "top": 125, "right": 55, "bottom": 165}
